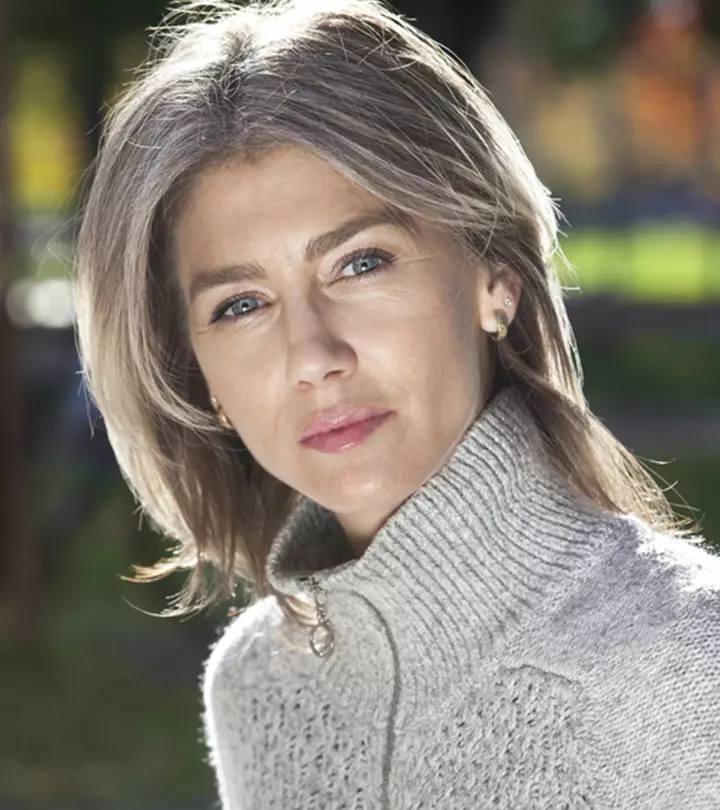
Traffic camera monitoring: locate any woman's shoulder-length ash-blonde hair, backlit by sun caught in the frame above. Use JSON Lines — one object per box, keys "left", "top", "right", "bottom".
{"left": 76, "top": 0, "right": 696, "bottom": 624}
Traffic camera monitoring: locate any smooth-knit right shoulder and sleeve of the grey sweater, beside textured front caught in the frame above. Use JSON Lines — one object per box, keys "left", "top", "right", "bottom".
{"left": 564, "top": 517, "right": 720, "bottom": 808}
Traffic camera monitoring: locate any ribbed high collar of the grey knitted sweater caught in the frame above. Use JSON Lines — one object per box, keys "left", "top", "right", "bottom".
{"left": 267, "top": 387, "right": 608, "bottom": 660}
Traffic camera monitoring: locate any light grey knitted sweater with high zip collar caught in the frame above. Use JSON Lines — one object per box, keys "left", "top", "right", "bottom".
{"left": 202, "top": 389, "right": 720, "bottom": 810}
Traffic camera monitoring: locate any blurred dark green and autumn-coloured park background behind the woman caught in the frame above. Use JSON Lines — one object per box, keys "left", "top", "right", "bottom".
{"left": 0, "top": 0, "right": 720, "bottom": 810}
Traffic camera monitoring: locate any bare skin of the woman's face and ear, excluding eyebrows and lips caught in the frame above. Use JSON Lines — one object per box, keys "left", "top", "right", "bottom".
{"left": 174, "top": 147, "right": 521, "bottom": 557}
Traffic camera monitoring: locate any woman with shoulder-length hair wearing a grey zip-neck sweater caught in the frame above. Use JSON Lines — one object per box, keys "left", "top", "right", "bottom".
{"left": 77, "top": 0, "right": 720, "bottom": 810}
